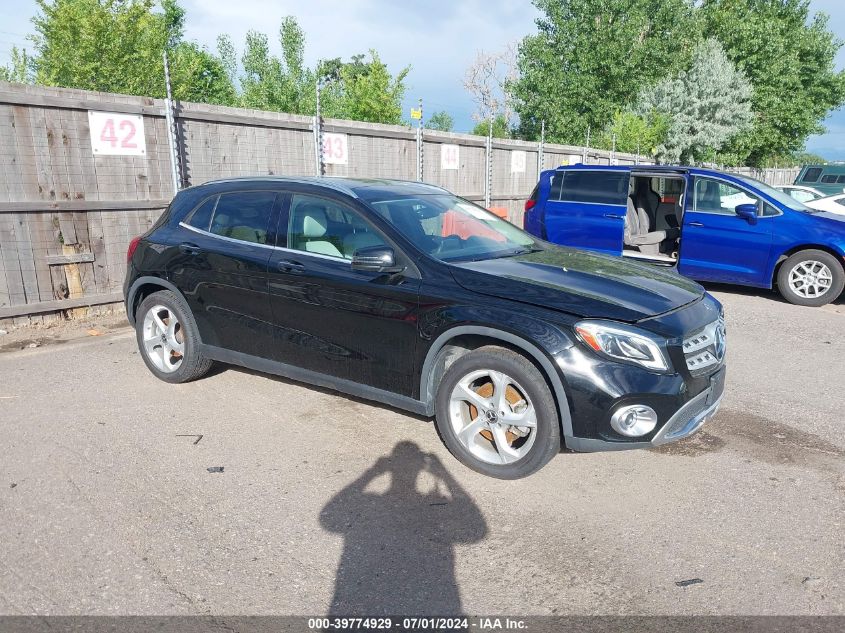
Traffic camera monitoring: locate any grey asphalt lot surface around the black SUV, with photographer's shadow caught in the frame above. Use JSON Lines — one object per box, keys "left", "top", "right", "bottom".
{"left": 0, "top": 286, "right": 845, "bottom": 615}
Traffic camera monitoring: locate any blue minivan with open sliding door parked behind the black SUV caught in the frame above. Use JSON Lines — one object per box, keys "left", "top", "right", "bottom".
{"left": 523, "top": 164, "right": 845, "bottom": 306}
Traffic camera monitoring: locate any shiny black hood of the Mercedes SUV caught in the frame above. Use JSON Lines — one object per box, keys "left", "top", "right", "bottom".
{"left": 452, "top": 246, "right": 704, "bottom": 322}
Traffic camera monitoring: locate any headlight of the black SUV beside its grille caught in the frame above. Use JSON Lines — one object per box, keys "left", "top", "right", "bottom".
{"left": 575, "top": 321, "right": 669, "bottom": 371}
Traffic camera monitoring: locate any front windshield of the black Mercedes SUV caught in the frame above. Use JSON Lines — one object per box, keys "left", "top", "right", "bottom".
{"left": 368, "top": 193, "right": 540, "bottom": 262}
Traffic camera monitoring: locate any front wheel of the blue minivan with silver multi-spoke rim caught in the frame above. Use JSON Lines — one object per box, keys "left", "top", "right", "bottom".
{"left": 778, "top": 250, "right": 845, "bottom": 307}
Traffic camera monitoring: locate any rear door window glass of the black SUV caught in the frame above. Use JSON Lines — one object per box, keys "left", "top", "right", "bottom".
{"left": 209, "top": 191, "right": 276, "bottom": 244}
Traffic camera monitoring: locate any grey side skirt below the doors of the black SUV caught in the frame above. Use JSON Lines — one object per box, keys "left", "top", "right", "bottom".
{"left": 202, "top": 345, "right": 434, "bottom": 416}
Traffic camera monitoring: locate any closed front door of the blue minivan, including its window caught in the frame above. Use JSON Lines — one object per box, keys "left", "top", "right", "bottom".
{"left": 678, "top": 176, "right": 780, "bottom": 286}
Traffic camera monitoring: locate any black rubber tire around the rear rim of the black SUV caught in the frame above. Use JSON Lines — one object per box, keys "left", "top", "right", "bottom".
{"left": 135, "top": 290, "right": 212, "bottom": 383}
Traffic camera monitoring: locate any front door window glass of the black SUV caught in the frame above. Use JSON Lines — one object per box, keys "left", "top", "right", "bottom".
{"left": 288, "top": 194, "right": 387, "bottom": 259}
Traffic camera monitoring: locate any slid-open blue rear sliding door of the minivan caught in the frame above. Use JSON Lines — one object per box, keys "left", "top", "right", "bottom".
{"left": 544, "top": 169, "right": 631, "bottom": 255}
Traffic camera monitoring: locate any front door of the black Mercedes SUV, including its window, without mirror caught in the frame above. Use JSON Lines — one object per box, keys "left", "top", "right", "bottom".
{"left": 269, "top": 186, "right": 420, "bottom": 396}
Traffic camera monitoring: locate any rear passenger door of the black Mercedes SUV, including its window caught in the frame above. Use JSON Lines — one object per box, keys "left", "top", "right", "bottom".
{"left": 169, "top": 190, "right": 277, "bottom": 355}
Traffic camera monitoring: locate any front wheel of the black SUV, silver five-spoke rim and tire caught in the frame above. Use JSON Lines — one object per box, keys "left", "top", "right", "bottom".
{"left": 436, "top": 346, "right": 560, "bottom": 479}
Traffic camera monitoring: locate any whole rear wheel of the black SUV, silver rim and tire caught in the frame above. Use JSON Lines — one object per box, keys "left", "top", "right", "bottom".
{"left": 135, "top": 290, "right": 212, "bottom": 383}
